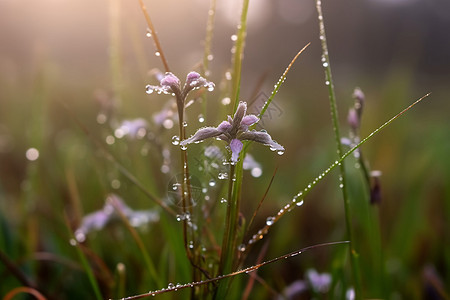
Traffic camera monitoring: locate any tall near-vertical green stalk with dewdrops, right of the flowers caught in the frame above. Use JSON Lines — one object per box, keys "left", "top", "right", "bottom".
{"left": 316, "top": 0, "right": 362, "bottom": 299}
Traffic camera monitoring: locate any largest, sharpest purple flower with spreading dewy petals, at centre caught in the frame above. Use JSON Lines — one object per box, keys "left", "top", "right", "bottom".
{"left": 180, "top": 102, "right": 284, "bottom": 163}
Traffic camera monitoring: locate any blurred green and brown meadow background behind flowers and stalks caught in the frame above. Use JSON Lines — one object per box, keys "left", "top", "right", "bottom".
{"left": 0, "top": 0, "right": 450, "bottom": 299}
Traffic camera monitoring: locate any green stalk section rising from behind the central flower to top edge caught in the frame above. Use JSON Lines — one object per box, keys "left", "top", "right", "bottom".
{"left": 231, "top": 0, "right": 250, "bottom": 112}
